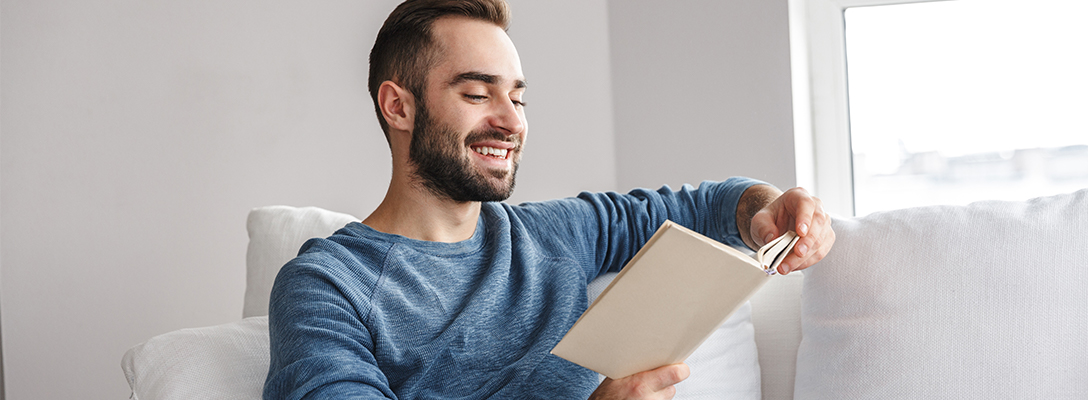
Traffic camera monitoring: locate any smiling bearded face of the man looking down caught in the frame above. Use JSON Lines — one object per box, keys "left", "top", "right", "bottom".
{"left": 408, "top": 17, "right": 528, "bottom": 201}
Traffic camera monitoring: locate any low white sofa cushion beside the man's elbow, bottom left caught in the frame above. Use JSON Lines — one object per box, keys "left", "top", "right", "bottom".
{"left": 121, "top": 316, "right": 269, "bottom": 400}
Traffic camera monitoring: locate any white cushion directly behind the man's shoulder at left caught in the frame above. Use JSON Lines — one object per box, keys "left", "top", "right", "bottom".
{"left": 242, "top": 205, "right": 359, "bottom": 317}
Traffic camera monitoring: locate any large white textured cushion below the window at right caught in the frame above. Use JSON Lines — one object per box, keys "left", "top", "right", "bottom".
{"left": 794, "top": 189, "right": 1088, "bottom": 400}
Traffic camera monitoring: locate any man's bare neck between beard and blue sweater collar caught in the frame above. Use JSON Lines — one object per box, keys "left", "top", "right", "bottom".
{"left": 362, "top": 179, "right": 481, "bottom": 242}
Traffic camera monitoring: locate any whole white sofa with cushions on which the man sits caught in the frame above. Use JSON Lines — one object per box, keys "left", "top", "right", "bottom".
{"left": 122, "top": 189, "right": 1088, "bottom": 400}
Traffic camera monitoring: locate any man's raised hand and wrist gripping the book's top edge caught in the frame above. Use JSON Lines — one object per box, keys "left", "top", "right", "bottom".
{"left": 737, "top": 185, "right": 834, "bottom": 275}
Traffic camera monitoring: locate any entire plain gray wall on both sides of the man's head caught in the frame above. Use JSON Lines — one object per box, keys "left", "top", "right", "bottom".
{"left": 0, "top": 0, "right": 793, "bottom": 400}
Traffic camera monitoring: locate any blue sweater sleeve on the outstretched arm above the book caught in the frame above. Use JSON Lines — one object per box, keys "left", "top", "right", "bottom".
{"left": 528, "top": 177, "right": 766, "bottom": 279}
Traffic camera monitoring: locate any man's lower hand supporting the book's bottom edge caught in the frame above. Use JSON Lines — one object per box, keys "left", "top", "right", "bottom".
{"left": 590, "top": 363, "right": 691, "bottom": 400}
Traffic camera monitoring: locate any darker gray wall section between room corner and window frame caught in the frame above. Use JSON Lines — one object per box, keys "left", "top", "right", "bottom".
{"left": 608, "top": 0, "right": 796, "bottom": 189}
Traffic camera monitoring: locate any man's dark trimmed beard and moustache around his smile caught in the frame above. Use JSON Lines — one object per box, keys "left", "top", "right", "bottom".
{"left": 408, "top": 104, "right": 521, "bottom": 202}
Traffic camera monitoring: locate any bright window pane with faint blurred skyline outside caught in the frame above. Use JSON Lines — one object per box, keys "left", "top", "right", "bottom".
{"left": 844, "top": 0, "right": 1088, "bottom": 215}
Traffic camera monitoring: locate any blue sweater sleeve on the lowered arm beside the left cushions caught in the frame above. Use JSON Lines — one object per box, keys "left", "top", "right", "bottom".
{"left": 264, "top": 241, "right": 396, "bottom": 400}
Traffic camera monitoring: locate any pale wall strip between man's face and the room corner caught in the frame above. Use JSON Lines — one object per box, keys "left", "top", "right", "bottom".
{"left": 509, "top": 0, "right": 616, "bottom": 203}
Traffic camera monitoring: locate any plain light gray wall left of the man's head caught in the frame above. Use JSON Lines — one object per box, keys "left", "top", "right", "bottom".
{"left": 0, "top": 0, "right": 395, "bottom": 400}
